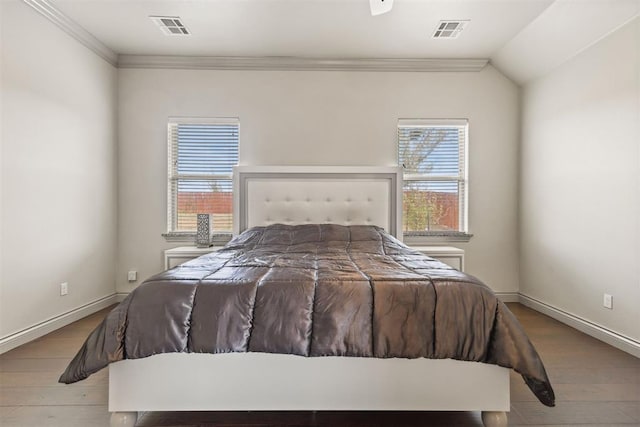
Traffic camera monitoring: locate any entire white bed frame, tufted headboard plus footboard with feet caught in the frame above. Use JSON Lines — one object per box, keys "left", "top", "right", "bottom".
{"left": 109, "top": 167, "right": 510, "bottom": 427}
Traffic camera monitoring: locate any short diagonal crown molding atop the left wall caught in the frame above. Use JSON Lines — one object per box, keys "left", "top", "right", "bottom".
{"left": 23, "top": 0, "right": 118, "bottom": 67}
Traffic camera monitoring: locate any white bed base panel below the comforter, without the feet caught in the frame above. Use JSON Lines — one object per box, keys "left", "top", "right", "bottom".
{"left": 109, "top": 353, "right": 509, "bottom": 412}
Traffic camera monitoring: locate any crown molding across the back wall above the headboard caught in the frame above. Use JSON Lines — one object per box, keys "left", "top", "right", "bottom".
{"left": 118, "top": 55, "right": 488, "bottom": 72}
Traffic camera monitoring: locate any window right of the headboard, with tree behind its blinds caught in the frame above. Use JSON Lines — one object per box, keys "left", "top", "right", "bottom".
{"left": 398, "top": 119, "right": 468, "bottom": 236}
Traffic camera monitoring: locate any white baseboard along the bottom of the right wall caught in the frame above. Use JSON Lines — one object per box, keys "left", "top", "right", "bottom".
{"left": 520, "top": 293, "right": 640, "bottom": 357}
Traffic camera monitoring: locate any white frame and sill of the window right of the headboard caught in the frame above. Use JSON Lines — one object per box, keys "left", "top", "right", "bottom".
{"left": 396, "top": 118, "right": 473, "bottom": 244}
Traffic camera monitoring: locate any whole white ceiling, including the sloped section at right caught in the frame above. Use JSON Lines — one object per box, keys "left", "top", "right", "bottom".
{"left": 36, "top": 0, "right": 640, "bottom": 83}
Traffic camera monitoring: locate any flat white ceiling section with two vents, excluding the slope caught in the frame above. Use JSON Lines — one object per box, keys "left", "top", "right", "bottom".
{"left": 54, "top": 0, "right": 552, "bottom": 58}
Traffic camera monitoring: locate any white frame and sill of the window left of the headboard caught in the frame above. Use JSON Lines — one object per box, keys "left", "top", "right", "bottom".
{"left": 162, "top": 117, "right": 240, "bottom": 244}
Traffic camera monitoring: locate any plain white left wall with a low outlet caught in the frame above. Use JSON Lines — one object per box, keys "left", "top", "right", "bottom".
{"left": 0, "top": 1, "right": 117, "bottom": 339}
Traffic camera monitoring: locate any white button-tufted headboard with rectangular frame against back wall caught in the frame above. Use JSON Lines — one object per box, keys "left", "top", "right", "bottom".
{"left": 233, "top": 166, "right": 402, "bottom": 238}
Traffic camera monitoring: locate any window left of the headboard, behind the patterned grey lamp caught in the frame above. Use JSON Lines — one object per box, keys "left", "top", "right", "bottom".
{"left": 167, "top": 119, "right": 240, "bottom": 235}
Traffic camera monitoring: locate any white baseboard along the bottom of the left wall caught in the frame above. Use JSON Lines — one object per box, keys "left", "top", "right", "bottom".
{"left": 0, "top": 293, "right": 119, "bottom": 354}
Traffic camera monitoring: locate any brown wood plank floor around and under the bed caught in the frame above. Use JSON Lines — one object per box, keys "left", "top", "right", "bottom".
{"left": 0, "top": 304, "right": 640, "bottom": 427}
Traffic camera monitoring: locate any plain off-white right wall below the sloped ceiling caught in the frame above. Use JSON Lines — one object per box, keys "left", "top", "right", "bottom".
{"left": 520, "top": 18, "right": 640, "bottom": 340}
